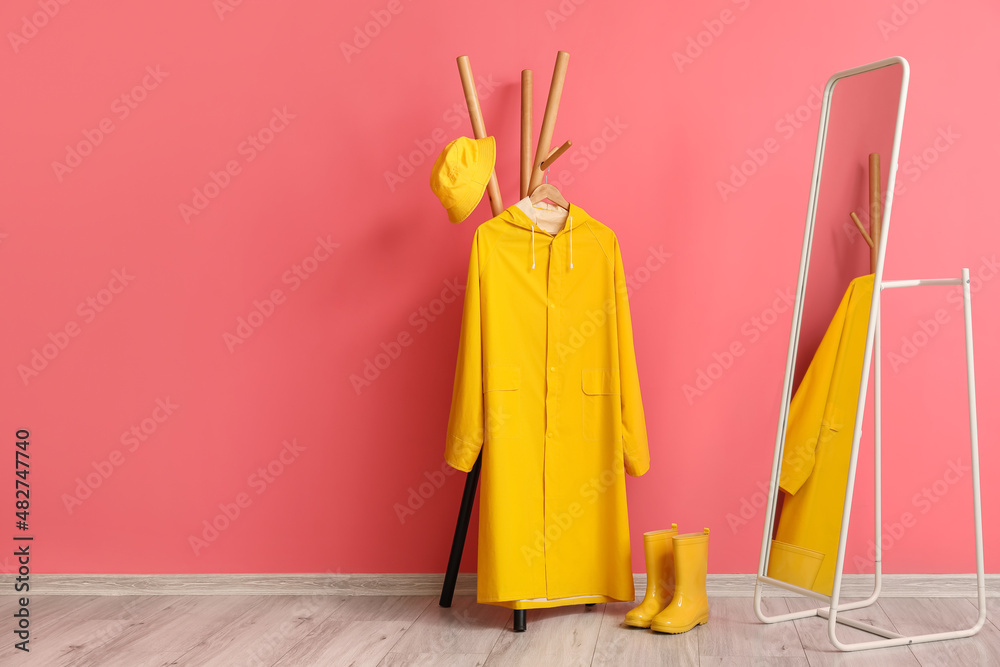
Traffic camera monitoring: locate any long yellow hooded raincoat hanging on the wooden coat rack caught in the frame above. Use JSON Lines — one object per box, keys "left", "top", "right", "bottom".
{"left": 445, "top": 205, "right": 649, "bottom": 609}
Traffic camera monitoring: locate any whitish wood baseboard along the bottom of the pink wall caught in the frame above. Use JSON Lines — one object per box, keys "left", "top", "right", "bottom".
{"left": 0, "top": 574, "right": 1000, "bottom": 598}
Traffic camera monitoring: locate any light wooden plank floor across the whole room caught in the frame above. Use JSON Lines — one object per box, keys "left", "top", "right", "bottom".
{"left": 9, "top": 595, "right": 1000, "bottom": 667}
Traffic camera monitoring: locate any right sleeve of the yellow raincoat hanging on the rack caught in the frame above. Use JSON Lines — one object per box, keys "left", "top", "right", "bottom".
{"left": 615, "top": 239, "right": 649, "bottom": 477}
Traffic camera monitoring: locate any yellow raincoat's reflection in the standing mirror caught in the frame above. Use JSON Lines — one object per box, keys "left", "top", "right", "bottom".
{"left": 768, "top": 275, "right": 874, "bottom": 595}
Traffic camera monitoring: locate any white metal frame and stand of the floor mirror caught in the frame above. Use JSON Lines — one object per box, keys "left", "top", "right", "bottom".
{"left": 754, "top": 57, "right": 986, "bottom": 651}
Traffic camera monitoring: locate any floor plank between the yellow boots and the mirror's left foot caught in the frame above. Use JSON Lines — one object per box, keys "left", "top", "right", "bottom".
{"left": 698, "top": 598, "right": 806, "bottom": 659}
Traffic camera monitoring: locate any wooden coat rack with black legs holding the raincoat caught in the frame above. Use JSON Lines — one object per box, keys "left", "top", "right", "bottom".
{"left": 440, "top": 51, "right": 576, "bottom": 632}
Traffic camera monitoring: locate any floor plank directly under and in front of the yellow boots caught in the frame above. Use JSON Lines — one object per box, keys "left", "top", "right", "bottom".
{"left": 592, "top": 602, "right": 703, "bottom": 667}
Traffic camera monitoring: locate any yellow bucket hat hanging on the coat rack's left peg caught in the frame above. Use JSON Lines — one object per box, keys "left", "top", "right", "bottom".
{"left": 431, "top": 137, "right": 497, "bottom": 224}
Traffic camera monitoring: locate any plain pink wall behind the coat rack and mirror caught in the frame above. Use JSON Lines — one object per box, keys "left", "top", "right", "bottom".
{"left": 0, "top": 0, "right": 1000, "bottom": 573}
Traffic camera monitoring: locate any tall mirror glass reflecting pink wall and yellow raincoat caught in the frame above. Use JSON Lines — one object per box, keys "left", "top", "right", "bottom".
{"left": 766, "top": 63, "right": 904, "bottom": 595}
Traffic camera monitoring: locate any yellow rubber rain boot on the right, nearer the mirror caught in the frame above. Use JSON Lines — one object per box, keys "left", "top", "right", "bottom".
{"left": 650, "top": 528, "right": 708, "bottom": 634}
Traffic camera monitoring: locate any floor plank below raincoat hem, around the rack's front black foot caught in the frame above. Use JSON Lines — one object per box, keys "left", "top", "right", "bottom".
{"left": 486, "top": 604, "right": 605, "bottom": 667}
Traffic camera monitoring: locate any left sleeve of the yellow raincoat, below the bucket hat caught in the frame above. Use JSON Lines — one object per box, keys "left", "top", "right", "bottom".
{"left": 444, "top": 232, "right": 483, "bottom": 472}
